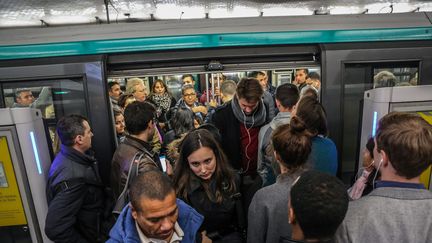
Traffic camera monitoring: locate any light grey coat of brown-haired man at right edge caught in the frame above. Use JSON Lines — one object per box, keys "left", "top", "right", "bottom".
{"left": 336, "top": 187, "right": 432, "bottom": 243}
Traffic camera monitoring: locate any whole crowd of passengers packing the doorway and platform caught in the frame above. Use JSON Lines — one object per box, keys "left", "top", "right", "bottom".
{"left": 41, "top": 69, "right": 432, "bottom": 243}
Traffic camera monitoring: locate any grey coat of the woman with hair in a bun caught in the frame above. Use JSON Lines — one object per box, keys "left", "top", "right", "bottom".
{"left": 247, "top": 173, "right": 298, "bottom": 243}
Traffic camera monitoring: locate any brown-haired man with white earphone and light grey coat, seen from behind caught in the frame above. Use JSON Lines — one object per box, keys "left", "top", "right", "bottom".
{"left": 336, "top": 112, "right": 432, "bottom": 243}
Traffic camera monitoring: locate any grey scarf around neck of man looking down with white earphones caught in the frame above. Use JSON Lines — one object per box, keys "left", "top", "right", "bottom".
{"left": 231, "top": 96, "right": 267, "bottom": 128}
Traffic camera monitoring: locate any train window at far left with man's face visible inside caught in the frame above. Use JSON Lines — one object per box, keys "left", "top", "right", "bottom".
{"left": 2, "top": 79, "right": 88, "bottom": 152}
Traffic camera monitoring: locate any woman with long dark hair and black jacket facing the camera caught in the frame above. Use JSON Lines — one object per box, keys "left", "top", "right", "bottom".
{"left": 174, "top": 129, "right": 243, "bottom": 243}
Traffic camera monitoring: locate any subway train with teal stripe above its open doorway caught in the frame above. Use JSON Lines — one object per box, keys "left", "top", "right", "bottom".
{"left": 0, "top": 12, "right": 432, "bottom": 241}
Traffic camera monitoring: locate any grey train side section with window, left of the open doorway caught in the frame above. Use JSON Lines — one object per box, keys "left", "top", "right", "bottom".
{"left": 0, "top": 58, "right": 115, "bottom": 183}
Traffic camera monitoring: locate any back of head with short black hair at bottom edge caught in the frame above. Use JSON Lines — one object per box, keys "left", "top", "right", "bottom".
{"left": 281, "top": 171, "right": 350, "bottom": 242}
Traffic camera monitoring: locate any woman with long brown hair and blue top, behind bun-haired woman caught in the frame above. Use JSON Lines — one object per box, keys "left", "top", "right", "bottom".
{"left": 291, "top": 96, "right": 338, "bottom": 176}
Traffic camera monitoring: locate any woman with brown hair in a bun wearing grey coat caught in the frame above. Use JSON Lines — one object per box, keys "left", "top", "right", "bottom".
{"left": 247, "top": 117, "right": 313, "bottom": 243}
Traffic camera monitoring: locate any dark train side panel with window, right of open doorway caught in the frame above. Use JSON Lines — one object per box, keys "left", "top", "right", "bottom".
{"left": 341, "top": 62, "right": 419, "bottom": 177}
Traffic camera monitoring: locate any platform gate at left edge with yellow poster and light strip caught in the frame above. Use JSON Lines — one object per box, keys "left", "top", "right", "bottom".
{"left": 0, "top": 108, "right": 51, "bottom": 243}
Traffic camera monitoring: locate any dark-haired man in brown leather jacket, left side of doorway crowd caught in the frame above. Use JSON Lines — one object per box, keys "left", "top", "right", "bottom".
{"left": 111, "top": 101, "right": 162, "bottom": 198}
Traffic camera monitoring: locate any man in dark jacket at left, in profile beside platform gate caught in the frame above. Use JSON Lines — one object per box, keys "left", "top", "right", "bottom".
{"left": 45, "top": 115, "right": 108, "bottom": 242}
